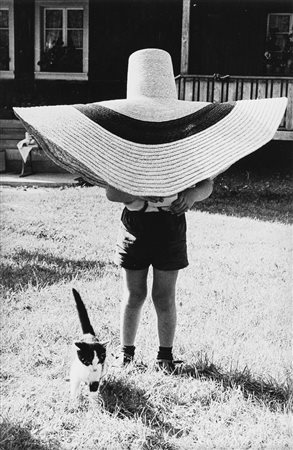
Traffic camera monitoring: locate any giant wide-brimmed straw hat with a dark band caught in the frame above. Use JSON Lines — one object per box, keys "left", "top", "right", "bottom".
{"left": 14, "top": 49, "right": 287, "bottom": 196}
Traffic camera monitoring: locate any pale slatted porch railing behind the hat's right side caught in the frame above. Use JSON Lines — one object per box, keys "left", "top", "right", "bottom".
{"left": 176, "top": 75, "right": 293, "bottom": 140}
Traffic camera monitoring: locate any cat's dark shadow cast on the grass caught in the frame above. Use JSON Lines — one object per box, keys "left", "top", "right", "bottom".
{"left": 100, "top": 379, "right": 183, "bottom": 442}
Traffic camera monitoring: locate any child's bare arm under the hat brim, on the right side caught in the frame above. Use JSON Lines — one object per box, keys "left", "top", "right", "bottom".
{"left": 170, "top": 179, "right": 214, "bottom": 216}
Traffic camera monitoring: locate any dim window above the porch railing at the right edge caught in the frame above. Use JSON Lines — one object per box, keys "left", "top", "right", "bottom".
{"left": 264, "top": 13, "right": 293, "bottom": 75}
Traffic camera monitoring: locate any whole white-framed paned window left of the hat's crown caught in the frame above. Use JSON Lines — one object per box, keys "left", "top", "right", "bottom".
{"left": 35, "top": 0, "right": 88, "bottom": 79}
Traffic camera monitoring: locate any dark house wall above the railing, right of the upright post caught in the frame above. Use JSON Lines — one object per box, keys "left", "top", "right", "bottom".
{"left": 186, "top": 0, "right": 293, "bottom": 76}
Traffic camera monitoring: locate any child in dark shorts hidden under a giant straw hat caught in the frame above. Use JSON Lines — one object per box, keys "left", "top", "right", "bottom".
{"left": 14, "top": 49, "right": 287, "bottom": 370}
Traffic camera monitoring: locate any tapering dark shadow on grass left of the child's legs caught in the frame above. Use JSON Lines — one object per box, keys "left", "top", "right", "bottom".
{"left": 0, "top": 249, "right": 114, "bottom": 291}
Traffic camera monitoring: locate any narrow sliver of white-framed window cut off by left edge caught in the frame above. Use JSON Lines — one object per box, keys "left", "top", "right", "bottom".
{"left": 0, "top": 0, "right": 14, "bottom": 78}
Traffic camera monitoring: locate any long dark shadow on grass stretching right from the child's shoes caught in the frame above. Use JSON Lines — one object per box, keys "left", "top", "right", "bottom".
{"left": 175, "top": 358, "right": 293, "bottom": 411}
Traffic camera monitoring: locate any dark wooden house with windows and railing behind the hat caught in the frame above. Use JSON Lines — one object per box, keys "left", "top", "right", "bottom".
{"left": 0, "top": 0, "right": 293, "bottom": 171}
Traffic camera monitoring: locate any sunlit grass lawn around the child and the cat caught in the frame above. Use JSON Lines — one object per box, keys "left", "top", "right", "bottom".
{"left": 0, "top": 173, "right": 292, "bottom": 450}
